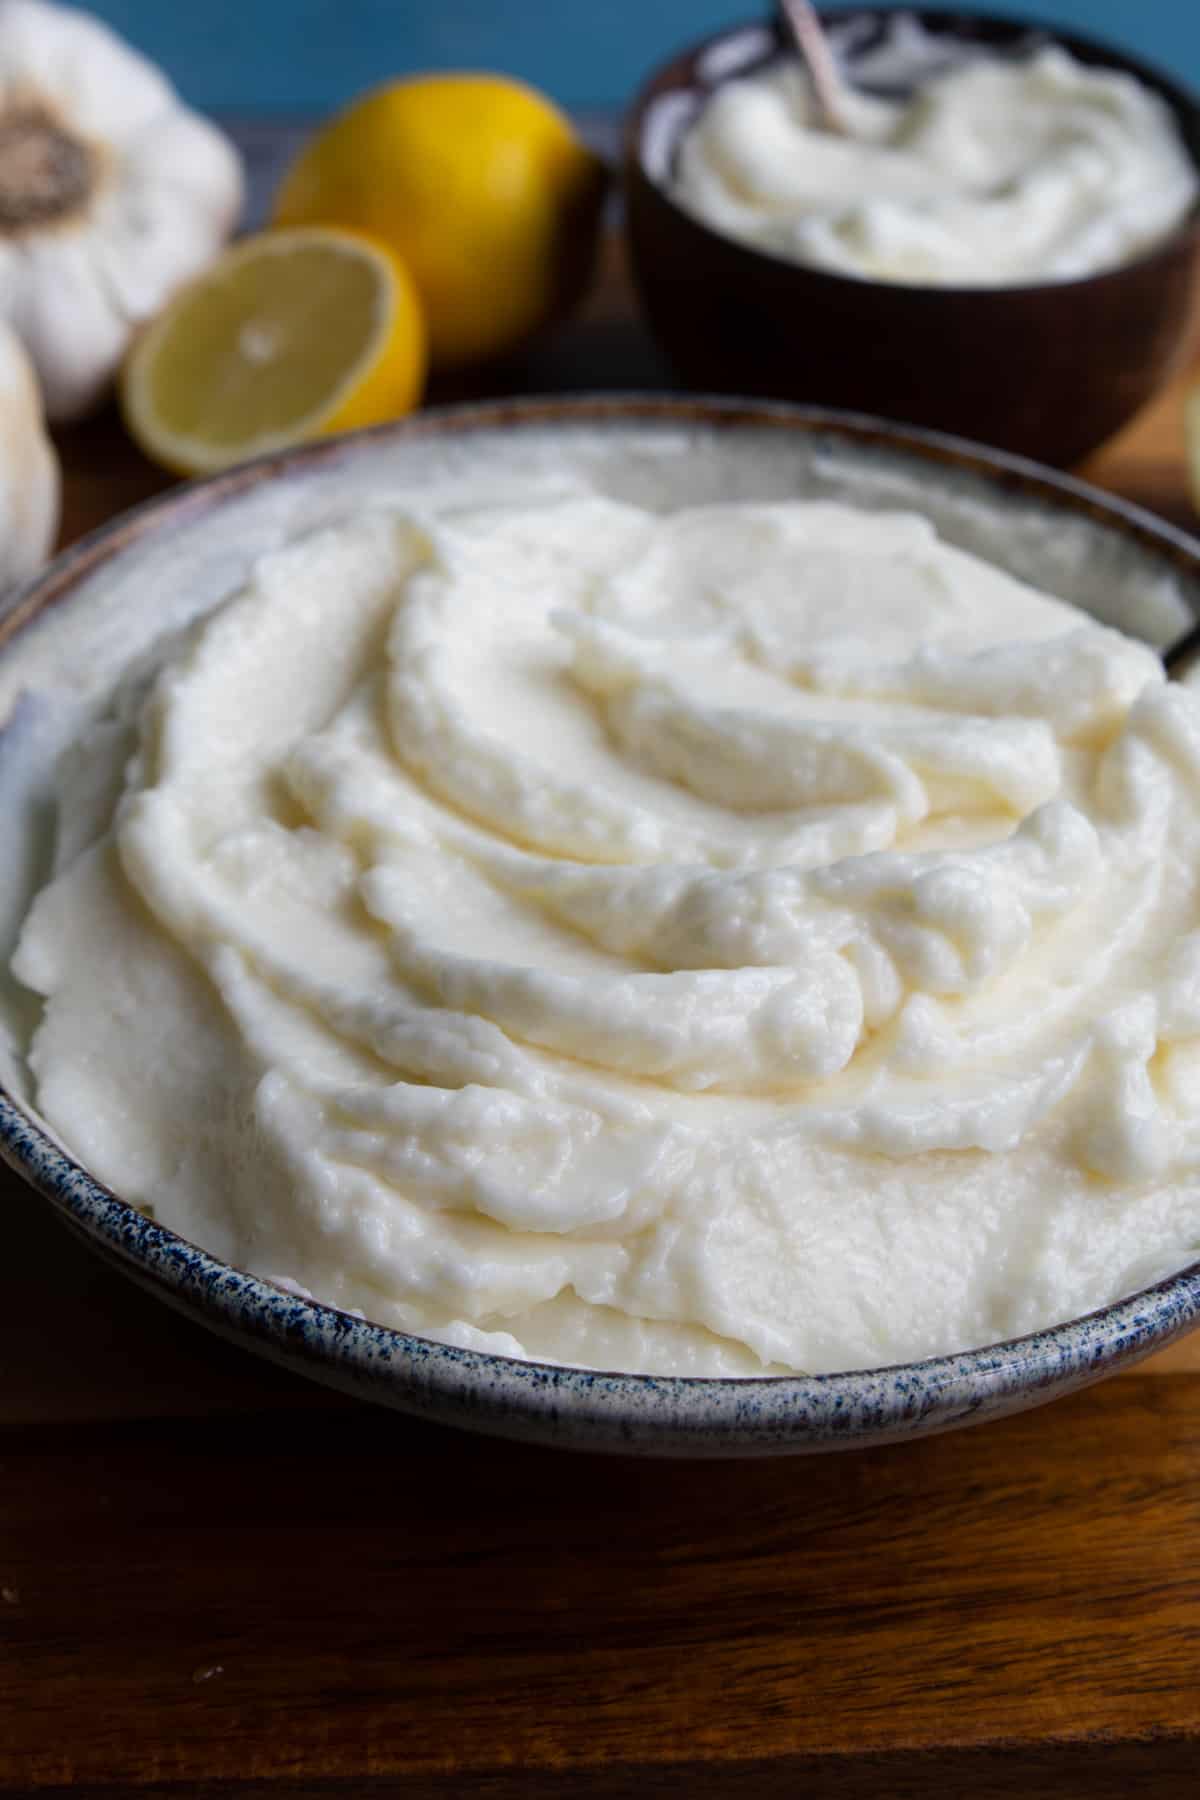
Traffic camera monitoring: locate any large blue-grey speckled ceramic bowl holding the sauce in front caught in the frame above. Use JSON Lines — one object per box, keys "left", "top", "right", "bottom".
{"left": 0, "top": 398, "right": 1200, "bottom": 1456}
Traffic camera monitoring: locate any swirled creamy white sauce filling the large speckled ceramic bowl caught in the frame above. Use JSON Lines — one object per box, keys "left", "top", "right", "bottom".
{"left": 14, "top": 497, "right": 1200, "bottom": 1375}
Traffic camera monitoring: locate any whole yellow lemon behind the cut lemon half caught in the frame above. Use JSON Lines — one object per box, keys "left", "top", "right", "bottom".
{"left": 273, "top": 74, "right": 606, "bottom": 369}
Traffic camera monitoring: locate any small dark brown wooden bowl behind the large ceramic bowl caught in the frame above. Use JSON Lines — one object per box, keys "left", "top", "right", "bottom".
{"left": 624, "top": 7, "right": 1200, "bottom": 466}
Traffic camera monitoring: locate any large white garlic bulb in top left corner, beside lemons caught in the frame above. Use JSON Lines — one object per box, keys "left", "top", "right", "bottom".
{"left": 0, "top": 0, "right": 243, "bottom": 419}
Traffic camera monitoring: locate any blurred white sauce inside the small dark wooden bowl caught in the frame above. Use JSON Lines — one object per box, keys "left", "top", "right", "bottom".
{"left": 673, "top": 47, "right": 1198, "bottom": 286}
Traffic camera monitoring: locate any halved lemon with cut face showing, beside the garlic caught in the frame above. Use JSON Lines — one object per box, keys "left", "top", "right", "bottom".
{"left": 121, "top": 227, "right": 426, "bottom": 475}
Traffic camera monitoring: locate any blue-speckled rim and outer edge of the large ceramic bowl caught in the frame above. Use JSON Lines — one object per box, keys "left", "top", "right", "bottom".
{"left": 0, "top": 394, "right": 1200, "bottom": 1456}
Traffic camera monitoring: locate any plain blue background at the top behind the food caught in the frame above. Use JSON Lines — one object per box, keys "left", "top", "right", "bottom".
{"left": 79, "top": 0, "right": 1200, "bottom": 112}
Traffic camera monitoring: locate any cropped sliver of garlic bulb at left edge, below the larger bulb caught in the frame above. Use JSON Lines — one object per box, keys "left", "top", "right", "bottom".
{"left": 0, "top": 313, "right": 59, "bottom": 590}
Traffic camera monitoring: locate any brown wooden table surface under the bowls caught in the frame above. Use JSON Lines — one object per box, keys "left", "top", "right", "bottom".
{"left": 0, "top": 239, "right": 1200, "bottom": 1800}
